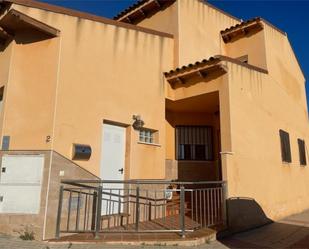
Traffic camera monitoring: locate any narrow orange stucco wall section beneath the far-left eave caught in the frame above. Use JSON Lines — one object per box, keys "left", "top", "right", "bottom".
{"left": 1, "top": 31, "right": 59, "bottom": 150}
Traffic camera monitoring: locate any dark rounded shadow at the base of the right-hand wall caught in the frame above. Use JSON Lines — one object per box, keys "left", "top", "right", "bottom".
{"left": 218, "top": 197, "right": 273, "bottom": 238}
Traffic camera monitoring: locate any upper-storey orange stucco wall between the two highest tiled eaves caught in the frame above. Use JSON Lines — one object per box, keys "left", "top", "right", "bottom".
{"left": 138, "top": 0, "right": 239, "bottom": 67}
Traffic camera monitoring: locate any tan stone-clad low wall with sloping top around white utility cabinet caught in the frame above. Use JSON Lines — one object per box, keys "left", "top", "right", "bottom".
{"left": 0, "top": 151, "right": 98, "bottom": 240}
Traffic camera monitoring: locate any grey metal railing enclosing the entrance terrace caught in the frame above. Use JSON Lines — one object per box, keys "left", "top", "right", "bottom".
{"left": 56, "top": 180, "right": 226, "bottom": 238}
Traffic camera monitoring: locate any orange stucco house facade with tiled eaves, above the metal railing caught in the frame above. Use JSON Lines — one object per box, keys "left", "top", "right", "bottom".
{"left": 0, "top": 0, "right": 309, "bottom": 239}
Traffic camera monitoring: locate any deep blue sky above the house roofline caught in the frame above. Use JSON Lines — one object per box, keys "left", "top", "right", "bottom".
{"left": 44, "top": 0, "right": 309, "bottom": 106}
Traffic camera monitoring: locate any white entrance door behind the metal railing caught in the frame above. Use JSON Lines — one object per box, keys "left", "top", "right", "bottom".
{"left": 100, "top": 124, "right": 126, "bottom": 215}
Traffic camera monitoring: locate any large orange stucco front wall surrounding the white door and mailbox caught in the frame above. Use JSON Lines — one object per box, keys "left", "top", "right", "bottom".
{"left": 4, "top": 5, "right": 174, "bottom": 179}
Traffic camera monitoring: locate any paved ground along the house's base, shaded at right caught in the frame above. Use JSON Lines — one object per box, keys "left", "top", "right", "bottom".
{"left": 4, "top": 210, "right": 309, "bottom": 249}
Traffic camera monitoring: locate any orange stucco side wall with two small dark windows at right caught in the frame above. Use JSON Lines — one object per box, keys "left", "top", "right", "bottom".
{"left": 227, "top": 63, "right": 309, "bottom": 219}
